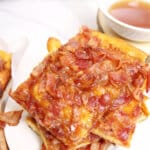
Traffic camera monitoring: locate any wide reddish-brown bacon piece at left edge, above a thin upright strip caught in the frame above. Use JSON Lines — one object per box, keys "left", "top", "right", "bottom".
{"left": 0, "top": 110, "right": 23, "bottom": 126}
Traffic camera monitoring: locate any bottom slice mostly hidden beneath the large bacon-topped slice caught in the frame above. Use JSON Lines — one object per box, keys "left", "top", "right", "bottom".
{"left": 26, "top": 117, "right": 110, "bottom": 150}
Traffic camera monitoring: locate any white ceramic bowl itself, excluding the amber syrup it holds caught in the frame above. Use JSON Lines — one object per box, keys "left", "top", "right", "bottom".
{"left": 98, "top": 0, "right": 150, "bottom": 42}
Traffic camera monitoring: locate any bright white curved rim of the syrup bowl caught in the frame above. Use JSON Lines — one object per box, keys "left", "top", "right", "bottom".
{"left": 98, "top": 0, "right": 150, "bottom": 33}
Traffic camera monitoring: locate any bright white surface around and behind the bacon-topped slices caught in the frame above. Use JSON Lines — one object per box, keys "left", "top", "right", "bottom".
{"left": 0, "top": 0, "right": 150, "bottom": 150}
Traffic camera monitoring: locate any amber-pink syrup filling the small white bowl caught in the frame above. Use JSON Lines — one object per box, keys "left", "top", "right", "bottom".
{"left": 109, "top": 0, "right": 150, "bottom": 28}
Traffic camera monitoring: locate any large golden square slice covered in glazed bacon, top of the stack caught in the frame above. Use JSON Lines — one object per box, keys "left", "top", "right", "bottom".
{"left": 11, "top": 28, "right": 150, "bottom": 149}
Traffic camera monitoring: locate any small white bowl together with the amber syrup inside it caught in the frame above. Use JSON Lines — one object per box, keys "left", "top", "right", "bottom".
{"left": 98, "top": 0, "right": 150, "bottom": 42}
